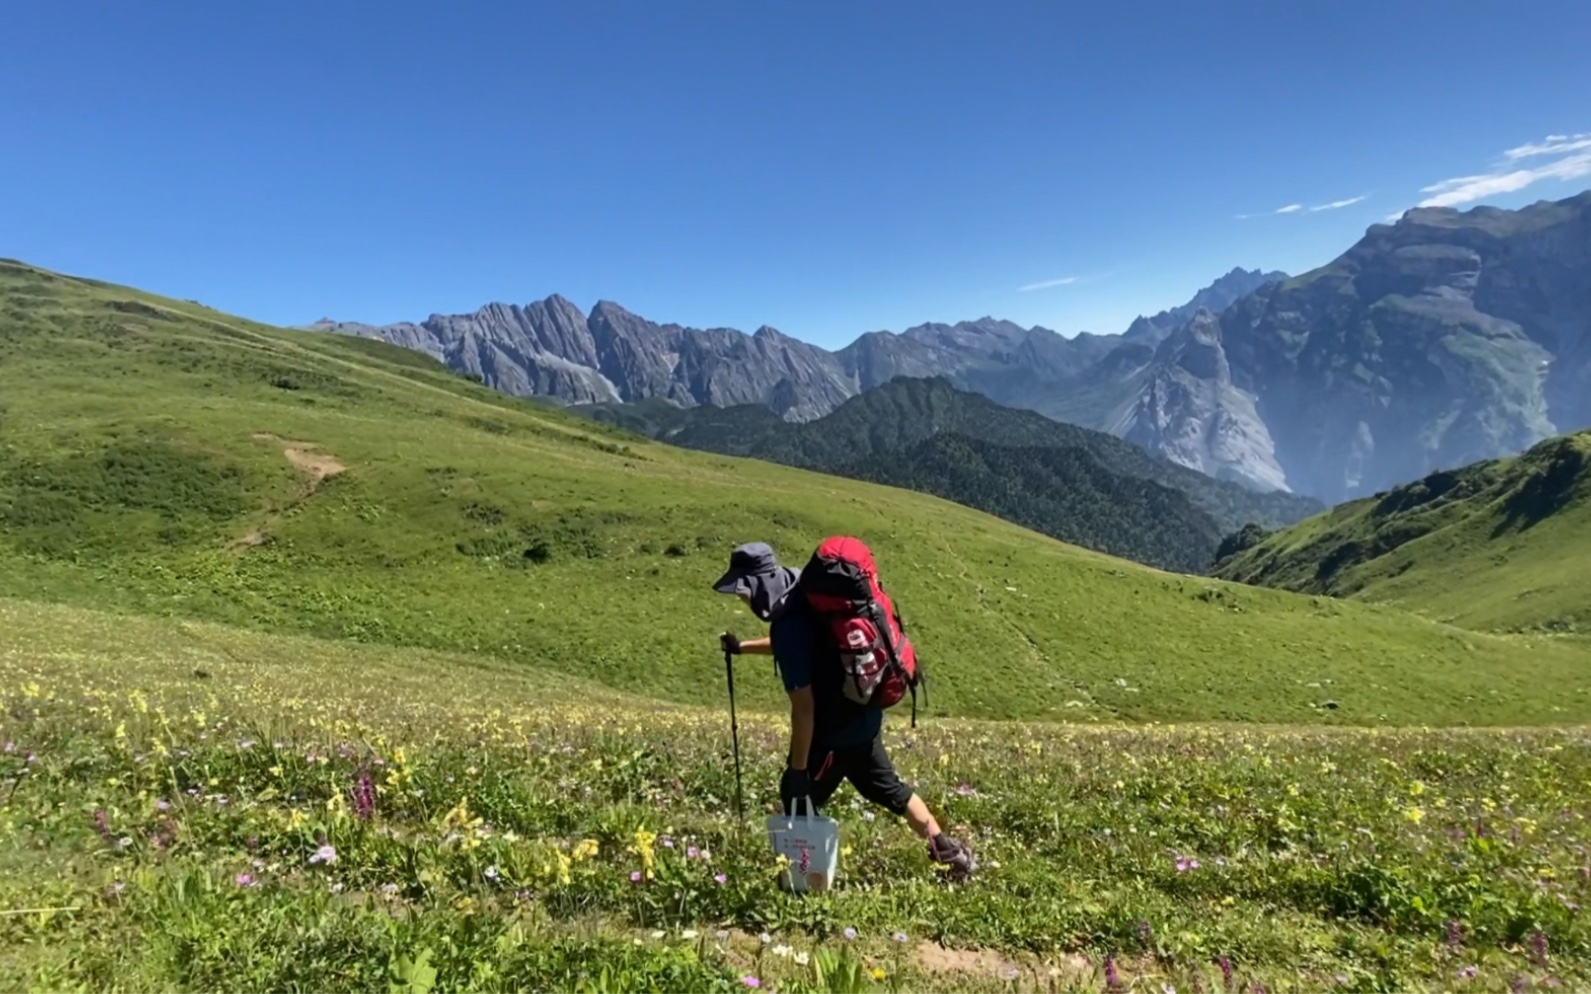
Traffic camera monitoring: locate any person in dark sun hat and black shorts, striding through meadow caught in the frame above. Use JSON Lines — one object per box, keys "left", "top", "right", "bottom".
{"left": 713, "top": 542, "right": 977, "bottom": 879}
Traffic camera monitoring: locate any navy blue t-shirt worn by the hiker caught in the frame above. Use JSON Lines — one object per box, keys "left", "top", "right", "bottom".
{"left": 768, "top": 601, "right": 885, "bottom": 752}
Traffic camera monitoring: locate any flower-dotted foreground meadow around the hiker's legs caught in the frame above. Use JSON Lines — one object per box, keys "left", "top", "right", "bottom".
{"left": 0, "top": 598, "right": 1591, "bottom": 994}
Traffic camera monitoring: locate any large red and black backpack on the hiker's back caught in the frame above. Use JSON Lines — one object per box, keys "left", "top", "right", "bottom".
{"left": 797, "top": 536, "right": 928, "bottom": 728}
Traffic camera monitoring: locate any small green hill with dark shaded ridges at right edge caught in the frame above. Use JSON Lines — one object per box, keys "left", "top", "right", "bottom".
{"left": 1219, "top": 433, "right": 1591, "bottom": 633}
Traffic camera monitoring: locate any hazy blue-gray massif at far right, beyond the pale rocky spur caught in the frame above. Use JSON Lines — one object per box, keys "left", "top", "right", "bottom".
{"left": 1220, "top": 194, "right": 1591, "bottom": 501}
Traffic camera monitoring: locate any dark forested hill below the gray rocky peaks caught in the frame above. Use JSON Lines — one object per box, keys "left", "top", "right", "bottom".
{"left": 570, "top": 377, "right": 1322, "bottom": 573}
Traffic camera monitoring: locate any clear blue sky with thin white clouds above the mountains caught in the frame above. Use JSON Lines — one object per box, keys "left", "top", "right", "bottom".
{"left": 0, "top": 0, "right": 1591, "bottom": 347}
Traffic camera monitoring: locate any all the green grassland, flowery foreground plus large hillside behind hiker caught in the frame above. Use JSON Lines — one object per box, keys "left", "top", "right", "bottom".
{"left": 0, "top": 262, "right": 1591, "bottom": 992}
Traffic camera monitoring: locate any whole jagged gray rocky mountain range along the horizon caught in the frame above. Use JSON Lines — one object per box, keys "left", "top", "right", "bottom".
{"left": 313, "top": 192, "right": 1591, "bottom": 503}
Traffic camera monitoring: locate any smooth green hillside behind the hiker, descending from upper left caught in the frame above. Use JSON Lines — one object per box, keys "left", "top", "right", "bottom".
{"left": 0, "top": 256, "right": 1591, "bottom": 724}
